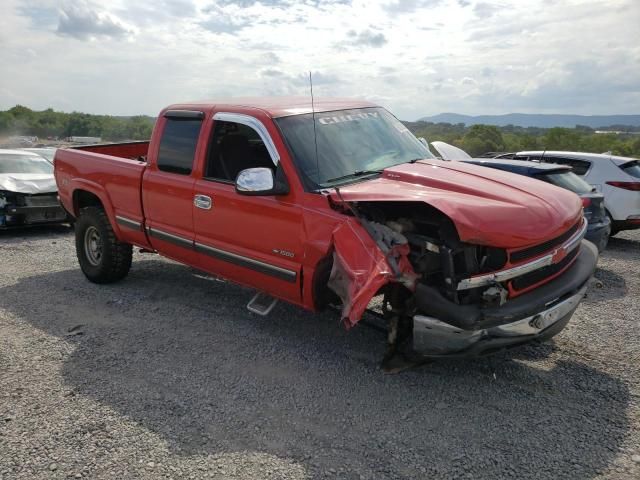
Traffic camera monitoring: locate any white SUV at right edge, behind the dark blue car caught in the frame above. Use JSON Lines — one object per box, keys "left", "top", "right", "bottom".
{"left": 496, "top": 151, "right": 640, "bottom": 235}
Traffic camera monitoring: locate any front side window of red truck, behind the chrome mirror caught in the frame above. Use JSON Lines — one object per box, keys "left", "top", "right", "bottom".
{"left": 205, "top": 120, "right": 276, "bottom": 182}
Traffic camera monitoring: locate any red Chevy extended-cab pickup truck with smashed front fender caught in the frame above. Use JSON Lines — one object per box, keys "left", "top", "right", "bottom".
{"left": 54, "top": 98, "right": 597, "bottom": 359}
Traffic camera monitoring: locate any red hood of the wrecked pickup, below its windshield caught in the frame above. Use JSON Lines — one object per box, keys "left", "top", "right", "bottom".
{"left": 329, "top": 159, "right": 582, "bottom": 248}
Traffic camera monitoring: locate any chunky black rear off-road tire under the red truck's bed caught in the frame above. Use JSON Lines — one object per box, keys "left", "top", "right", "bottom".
{"left": 75, "top": 207, "right": 133, "bottom": 283}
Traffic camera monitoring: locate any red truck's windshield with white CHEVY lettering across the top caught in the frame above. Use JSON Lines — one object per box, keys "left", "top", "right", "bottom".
{"left": 276, "top": 108, "right": 433, "bottom": 189}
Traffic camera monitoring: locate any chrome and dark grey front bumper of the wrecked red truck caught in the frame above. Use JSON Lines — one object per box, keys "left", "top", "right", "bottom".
{"left": 413, "top": 241, "right": 598, "bottom": 357}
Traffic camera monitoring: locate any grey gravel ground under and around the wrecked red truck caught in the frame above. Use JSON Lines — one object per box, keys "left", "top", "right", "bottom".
{"left": 0, "top": 227, "right": 640, "bottom": 480}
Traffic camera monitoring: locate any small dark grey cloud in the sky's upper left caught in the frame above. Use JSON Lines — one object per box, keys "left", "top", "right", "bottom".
{"left": 56, "top": 2, "right": 134, "bottom": 40}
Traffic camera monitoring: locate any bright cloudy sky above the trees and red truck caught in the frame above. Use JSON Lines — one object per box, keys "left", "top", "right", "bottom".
{"left": 0, "top": 0, "right": 640, "bottom": 120}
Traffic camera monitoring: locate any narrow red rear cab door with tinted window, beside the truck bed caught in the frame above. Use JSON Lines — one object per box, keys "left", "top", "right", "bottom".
{"left": 142, "top": 110, "right": 204, "bottom": 263}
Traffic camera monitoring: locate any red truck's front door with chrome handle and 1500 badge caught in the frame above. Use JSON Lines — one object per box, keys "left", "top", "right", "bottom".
{"left": 193, "top": 113, "right": 303, "bottom": 303}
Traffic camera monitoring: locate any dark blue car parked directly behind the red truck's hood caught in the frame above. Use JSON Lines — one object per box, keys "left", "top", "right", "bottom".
{"left": 461, "top": 158, "right": 611, "bottom": 251}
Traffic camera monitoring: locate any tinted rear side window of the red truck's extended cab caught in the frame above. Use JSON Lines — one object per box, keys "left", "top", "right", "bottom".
{"left": 158, "top": 112, "right": 202, "bottom": 175}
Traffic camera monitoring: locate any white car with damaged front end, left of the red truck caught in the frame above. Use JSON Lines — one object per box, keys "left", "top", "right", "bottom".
{"left": 0, "top": 150, "right": 68, "bottom": 229}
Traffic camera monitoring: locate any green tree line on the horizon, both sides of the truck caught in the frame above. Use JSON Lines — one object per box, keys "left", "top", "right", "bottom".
{"left": 0, "top": 105, "right": 640, "bottom": 157}
